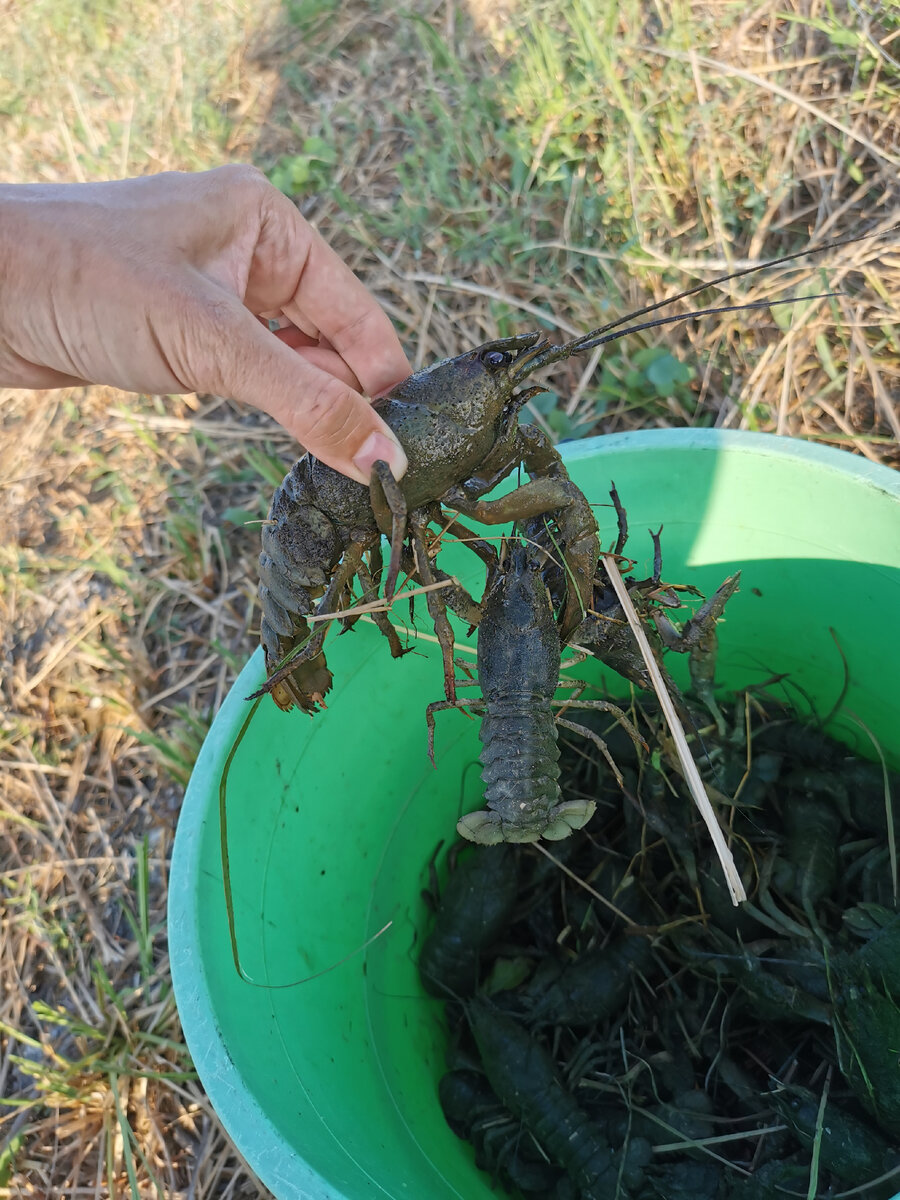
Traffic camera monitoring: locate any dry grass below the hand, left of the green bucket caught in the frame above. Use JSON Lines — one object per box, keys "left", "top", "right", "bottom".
{"left": 0, "top": 389, "right": 277, "bottom": 1198}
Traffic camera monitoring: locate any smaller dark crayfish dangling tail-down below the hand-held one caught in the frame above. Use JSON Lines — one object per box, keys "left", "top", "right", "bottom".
{"left": 426, "top": 501, "right": 739, "bottom": 845}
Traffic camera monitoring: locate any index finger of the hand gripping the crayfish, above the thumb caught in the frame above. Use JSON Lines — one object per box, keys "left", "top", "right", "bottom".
{"left": 282, "top": 222, "right": 412, "bottom": 396}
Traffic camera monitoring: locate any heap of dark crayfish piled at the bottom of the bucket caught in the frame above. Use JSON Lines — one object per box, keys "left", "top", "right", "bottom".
{"left": 419, "top": 694, "right": 900, "bottom": 1200}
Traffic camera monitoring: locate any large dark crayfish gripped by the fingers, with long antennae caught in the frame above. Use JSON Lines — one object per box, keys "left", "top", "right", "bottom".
{"left": 251, "top": 239, "right": 873, "bottom": 713}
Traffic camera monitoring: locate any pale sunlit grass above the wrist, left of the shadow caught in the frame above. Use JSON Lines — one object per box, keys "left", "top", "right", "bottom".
{"left": 0, "top": 0, "right": 271, "bottom": 180}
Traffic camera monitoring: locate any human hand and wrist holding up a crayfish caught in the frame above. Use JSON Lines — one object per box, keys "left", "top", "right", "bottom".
{"left": 0, "top": 167, "right": 409, "bottom": 484}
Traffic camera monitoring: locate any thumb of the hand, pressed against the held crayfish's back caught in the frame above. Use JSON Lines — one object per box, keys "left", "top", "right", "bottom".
{"left": 198, "top": 300, "right": 407, "bottom": 485}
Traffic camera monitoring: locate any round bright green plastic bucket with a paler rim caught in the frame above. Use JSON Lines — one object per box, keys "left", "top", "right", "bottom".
{"left": 169, "top": 430, "right": 900, "bottom": 1200}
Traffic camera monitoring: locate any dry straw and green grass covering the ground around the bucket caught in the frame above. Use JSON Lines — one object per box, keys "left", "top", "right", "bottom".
{"left": 0, "top": 0, "right": 900, "bottom": 1200}
